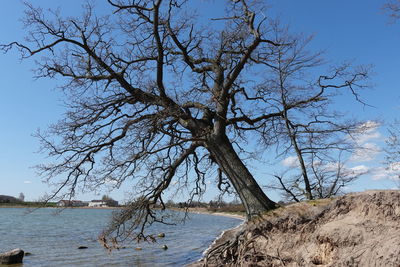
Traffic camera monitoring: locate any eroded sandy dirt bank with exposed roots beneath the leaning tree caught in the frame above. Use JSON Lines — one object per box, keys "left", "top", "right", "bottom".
{"left": 191, "top": 190, "right": 400, "bottom": 267}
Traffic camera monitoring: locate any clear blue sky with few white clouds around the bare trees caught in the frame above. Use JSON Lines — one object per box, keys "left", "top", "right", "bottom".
{"left": 0, "top": 0, "right": 400, "bottom": 203}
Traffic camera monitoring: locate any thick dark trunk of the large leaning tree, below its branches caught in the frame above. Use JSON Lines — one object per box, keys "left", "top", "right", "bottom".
{"left": 207, "top": 136, "right": 276, "bottom": 219}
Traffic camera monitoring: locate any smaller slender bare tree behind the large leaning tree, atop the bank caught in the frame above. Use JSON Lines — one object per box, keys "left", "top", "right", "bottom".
{"left": 248, "top": 25, "right": 368, "bottom": 201}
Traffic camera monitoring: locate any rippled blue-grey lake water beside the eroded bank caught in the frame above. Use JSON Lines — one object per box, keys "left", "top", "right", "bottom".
{"left": 0, "top": 208, "right": 241, "bottom": 267}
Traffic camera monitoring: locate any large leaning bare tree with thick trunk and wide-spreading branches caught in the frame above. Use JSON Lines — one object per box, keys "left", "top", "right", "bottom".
{"left": 1, "top": 0, "right": 366, "bottom": 247}
